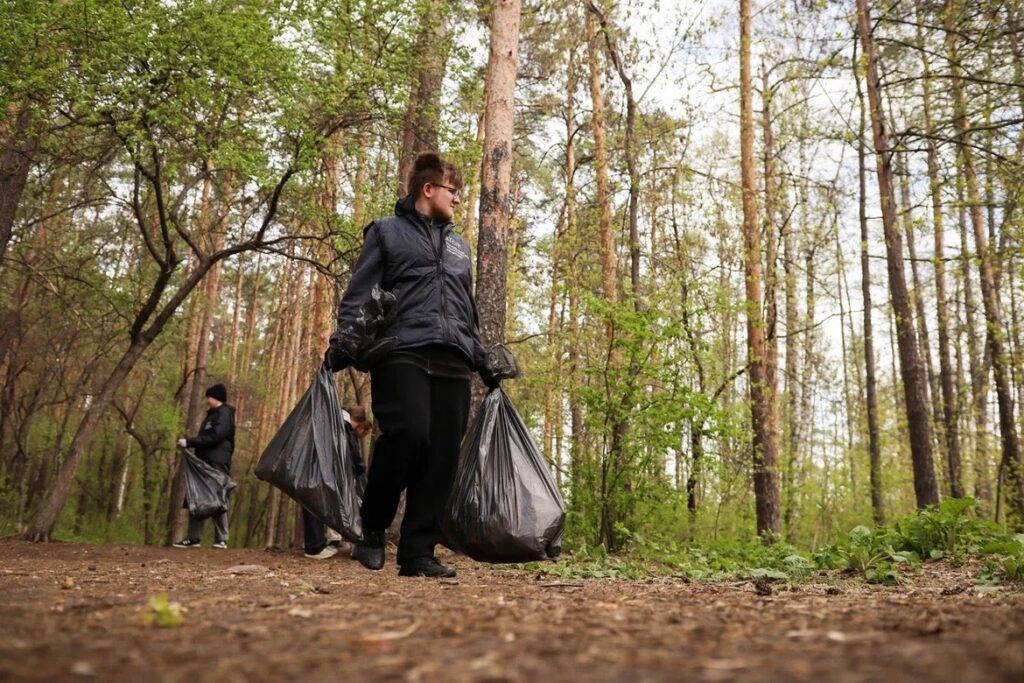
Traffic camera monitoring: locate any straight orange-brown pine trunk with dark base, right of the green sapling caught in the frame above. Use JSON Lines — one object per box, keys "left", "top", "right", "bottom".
{"left": 739, "top": 0, "right": 782, "bottom": 541}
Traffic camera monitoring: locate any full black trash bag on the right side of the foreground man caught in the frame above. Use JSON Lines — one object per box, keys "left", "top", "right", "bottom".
{"left": 441, "top": 388, "right": 565, "bottom": 563}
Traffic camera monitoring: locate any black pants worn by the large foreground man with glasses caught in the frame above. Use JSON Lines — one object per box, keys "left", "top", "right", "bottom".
{"left": 361, "top": 364, "right": 469, "bottom": 564}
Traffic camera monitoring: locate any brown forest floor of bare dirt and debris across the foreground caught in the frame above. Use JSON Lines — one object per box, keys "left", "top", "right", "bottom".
{"left": 0, "top": 541, "right": 1024, "bottom": 683}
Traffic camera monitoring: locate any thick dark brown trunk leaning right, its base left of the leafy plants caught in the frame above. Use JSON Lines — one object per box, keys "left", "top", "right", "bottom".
{"left": 857, "top": 0, "right": 939, "bottom": 508}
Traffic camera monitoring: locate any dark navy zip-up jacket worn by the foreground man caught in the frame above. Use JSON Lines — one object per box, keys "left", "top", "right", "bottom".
{"left": 329, "top": 197, "right": 486, "bottom": 370}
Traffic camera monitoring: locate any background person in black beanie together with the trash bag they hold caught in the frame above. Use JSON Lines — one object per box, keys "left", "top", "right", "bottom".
{"left": 173, "top": 384, "right": 234, "bottom": 549}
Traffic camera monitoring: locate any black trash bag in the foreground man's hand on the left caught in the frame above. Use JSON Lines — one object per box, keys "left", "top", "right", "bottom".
{"left": 256, "top": 366, "right": 365, "bottom": 541}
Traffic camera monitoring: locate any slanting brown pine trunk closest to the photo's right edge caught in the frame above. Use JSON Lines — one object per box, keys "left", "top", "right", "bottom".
{"left": 943, "top": 3, "right": 1024, "bottom": 520}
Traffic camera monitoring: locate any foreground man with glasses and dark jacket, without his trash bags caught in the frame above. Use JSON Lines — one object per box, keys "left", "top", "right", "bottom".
{"left": 327, "top": 153, "right": 496, "bottom": 577}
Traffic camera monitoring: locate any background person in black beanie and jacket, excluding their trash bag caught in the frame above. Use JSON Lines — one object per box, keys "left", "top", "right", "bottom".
{"left": 174, "top": 384, "right": 234, "bottom": 548}
